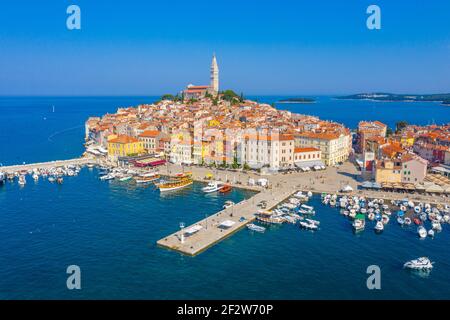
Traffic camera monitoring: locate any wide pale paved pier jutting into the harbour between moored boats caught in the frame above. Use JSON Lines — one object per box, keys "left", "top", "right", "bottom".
{"left": 157, "top": 188, "right": 296, "bottom": 256}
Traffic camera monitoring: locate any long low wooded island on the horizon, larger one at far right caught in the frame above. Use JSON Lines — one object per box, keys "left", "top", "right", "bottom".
{"left": 336, "top": 93, "right": 450, "bottom": 105}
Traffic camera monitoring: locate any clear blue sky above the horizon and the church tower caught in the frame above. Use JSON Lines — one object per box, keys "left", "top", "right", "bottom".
{"left": 0, "top": 0, "right": 450, "bottom": 95}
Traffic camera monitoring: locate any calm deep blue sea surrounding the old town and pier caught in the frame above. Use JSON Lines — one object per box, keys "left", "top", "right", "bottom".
{"left": 0, "top": 97, "right": 450, "bottom": 299}
